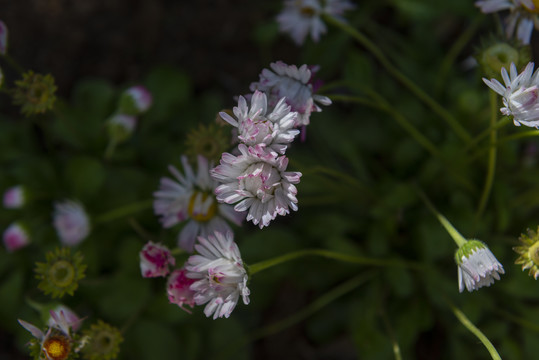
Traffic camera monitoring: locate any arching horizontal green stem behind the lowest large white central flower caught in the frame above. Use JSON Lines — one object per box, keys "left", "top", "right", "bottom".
{"left": 249, "top": 249, "right": 421, "bottom": 275}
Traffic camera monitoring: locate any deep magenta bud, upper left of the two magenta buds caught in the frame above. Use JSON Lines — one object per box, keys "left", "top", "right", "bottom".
{"left": 139, "top": 241, "right": 176, "bottom": 278}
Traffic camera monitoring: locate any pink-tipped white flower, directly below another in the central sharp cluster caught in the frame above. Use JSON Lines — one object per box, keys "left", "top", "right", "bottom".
{"left": 211, "top": 144, "right": 301, "bottom": 228}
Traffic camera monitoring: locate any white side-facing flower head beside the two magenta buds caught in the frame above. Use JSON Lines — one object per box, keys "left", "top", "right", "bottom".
{"left": 185, "top": 232, "right": 250, "bottom": 320}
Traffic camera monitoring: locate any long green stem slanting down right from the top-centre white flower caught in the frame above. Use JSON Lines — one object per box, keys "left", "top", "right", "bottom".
{"left": 324, "top": 15, "right": 472, "bottom": 142}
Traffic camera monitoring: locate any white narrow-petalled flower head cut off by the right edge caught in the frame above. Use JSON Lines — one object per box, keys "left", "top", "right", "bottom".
{"left": 483, "top": 63, "right": 539, "bottom": 128}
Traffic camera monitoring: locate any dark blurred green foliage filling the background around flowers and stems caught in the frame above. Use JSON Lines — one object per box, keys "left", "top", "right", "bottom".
{"left": 0, "top": 0, "right": 539, "bottom": 360}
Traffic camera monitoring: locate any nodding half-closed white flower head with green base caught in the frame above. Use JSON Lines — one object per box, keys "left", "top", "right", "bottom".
{"left": 455, "top": 240, "right": 505, "bottom": 292}
